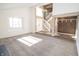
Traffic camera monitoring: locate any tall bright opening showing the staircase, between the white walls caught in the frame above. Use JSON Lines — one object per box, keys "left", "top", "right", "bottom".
{"left": 36, "top": 3, "right": 53, "bottom": 35}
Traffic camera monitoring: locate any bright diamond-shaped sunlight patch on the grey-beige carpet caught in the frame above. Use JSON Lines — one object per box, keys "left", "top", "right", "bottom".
{"left": 17, "top": 36, "right": 42, "bottom": 46}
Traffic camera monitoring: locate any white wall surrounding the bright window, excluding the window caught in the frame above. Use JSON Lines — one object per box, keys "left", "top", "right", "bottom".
{"left": 0, "top": 7, "right": 34, "bottom": 38}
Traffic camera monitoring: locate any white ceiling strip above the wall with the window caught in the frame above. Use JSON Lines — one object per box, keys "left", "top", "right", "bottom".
{"left": 0, "top": 3, "right": 43, "bottom": 9}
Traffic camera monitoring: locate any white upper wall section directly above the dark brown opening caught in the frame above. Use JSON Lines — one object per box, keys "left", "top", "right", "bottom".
{"left": 53, "top": 3, "right": 79, "bottom": 15}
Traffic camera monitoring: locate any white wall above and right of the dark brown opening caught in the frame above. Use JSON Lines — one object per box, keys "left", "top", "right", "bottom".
{"left": 53, "top": 3, "right": 79, "bottom": 55}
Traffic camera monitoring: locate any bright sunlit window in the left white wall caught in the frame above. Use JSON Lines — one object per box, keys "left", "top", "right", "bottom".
{"left": 9, "top": 17, "right": 22, "bottom": 28}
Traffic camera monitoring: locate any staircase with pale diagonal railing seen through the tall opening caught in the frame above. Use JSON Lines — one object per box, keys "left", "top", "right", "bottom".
{"left": 40, "top": 13, "right": 53, "bottom": 35}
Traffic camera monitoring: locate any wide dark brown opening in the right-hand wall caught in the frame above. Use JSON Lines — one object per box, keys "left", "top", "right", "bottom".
{"left": 57, "top": 16, "right": 77, "bottom": 38}
